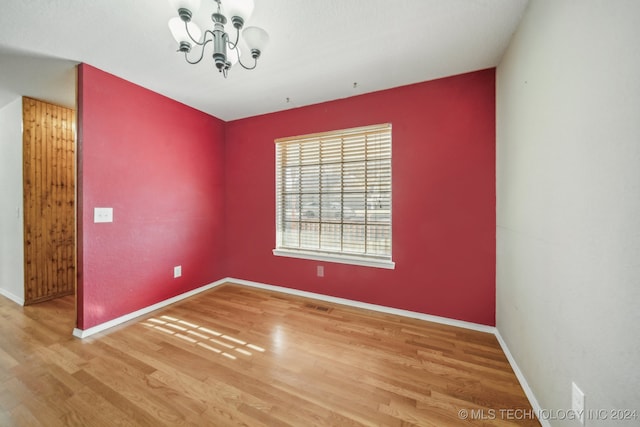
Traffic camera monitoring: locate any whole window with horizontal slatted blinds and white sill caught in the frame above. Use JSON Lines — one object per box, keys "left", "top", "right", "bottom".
{"left": 274, "top": 124, "right": 394, "bottom": 268}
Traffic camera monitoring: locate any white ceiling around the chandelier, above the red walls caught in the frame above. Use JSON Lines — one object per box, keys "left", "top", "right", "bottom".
{"left": 0, "top": 0, "right": 528, "bottom": 120}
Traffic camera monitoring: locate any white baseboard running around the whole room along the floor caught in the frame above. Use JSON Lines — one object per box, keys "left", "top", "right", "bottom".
{"left": 70, "top": 277, "right": 551, "bottom": 427}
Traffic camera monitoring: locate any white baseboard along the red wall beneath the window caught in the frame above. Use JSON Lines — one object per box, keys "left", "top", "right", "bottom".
{"left": 226, "top": 277, "right": 495, "bottom": 334}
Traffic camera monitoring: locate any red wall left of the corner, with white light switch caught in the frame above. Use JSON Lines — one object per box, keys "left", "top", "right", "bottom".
{"left": 78, "top": 64, "right": 227, "bottom": 329}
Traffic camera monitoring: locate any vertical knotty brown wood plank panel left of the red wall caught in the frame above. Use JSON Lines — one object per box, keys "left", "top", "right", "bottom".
{"left": 22, "top": 97, "right": 76, "bottom": 305}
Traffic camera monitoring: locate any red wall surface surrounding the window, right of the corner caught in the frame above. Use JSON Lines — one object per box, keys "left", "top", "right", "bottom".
{"left": 225, "top": 69, "right": 495, "bottom": 325}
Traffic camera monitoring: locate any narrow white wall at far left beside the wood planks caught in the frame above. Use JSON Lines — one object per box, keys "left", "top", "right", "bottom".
{"left": 0, "top": 97, "right": 24, "bottom": 305}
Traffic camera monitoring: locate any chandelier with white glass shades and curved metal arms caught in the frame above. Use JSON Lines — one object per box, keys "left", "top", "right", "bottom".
{"left": 169, "top": 0, "right": 269, "bottom": 78}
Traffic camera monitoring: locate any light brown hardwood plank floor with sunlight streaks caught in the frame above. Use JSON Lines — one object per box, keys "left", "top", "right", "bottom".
{"left": 0, "top": 284, "right": 540, "bottom": 427}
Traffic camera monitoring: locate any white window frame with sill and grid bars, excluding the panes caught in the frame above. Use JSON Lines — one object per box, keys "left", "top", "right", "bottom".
{"left": 273, "top": 123, "right": 395, "bottom": 269}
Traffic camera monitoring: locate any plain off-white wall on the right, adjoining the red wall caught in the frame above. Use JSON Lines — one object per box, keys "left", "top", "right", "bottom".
{"left": 496, "top": 0, "right": 640, "bottom": 427}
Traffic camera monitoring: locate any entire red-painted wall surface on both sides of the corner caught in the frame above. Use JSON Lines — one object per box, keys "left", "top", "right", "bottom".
{"left": 78, "top": 64, "right": 495, "bottom": 329}
